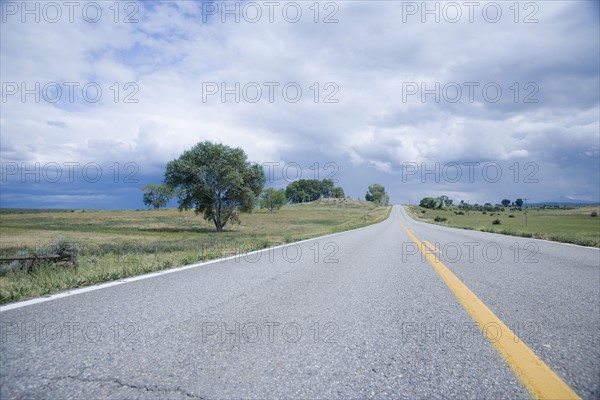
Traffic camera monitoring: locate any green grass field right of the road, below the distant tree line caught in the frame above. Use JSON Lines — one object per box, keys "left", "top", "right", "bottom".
{"left": 407, "top": 206, "right": 600, "bottom": 247}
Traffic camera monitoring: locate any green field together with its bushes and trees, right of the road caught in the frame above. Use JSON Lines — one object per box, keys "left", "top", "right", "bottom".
{"left": 406, "top": 196, "right": 600, "bottom": 247}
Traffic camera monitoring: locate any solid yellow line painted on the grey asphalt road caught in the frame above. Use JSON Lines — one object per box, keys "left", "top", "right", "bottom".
{"left": 402, "top": 224, "right": 579, "bottom": 399}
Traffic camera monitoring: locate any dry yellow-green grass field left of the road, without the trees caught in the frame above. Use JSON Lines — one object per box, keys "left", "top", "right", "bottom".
{"left": 0, "top": 199, "right": 391, "bottom": 304}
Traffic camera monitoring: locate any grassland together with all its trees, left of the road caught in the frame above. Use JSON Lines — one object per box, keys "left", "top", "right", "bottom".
{"left": 0, "top": 141, "right": 391, "bottom": 304}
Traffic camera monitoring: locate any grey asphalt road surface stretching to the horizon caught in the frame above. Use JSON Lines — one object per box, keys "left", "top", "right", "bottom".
{"left": 0, "top": 207, "right": 600, "bottom": 399}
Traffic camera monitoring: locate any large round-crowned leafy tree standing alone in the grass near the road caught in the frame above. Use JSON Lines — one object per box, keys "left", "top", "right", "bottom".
{"left": 164, "top": 142, "right": 265, "bottom": 232}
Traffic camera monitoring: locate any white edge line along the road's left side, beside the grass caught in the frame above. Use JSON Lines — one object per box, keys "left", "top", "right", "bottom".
{"left": 0, "top": 209, "right": 393, "bottom": 313}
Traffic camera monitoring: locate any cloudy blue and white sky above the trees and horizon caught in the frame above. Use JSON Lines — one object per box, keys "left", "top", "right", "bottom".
{"left": 0, "top": 0, "right": 600, "bottom": 209}
